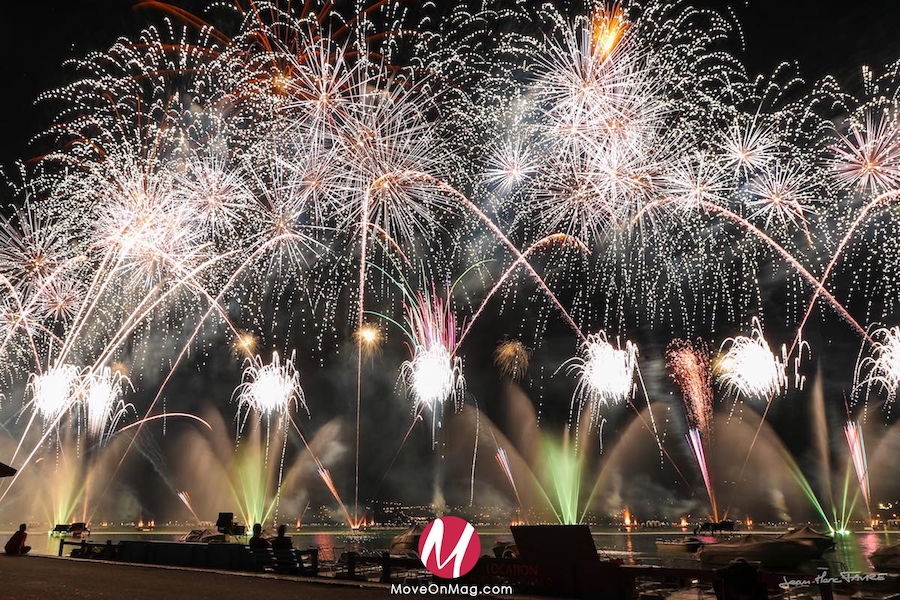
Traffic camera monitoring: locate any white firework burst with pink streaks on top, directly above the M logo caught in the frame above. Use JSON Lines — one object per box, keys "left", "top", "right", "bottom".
{"left": 401, "top": 288, "right": 465, "bottom": 511}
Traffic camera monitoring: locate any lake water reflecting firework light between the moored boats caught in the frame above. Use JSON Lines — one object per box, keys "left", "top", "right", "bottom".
{"left": 8, "top": 528, "right": 900, "bottom": 572}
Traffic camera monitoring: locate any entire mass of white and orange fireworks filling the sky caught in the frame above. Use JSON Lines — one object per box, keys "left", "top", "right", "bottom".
{"left": 0, "top": 0, "right": 900, "bottom": 527}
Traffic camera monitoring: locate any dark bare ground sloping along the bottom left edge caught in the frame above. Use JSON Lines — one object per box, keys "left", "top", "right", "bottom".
{"left": 0, "top": 554, "right": 439, "bottom": 600}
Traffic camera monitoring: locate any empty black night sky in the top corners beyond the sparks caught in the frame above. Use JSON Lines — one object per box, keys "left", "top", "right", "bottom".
{"left": 0, "top": 0, "right": 900, "bottom": 168}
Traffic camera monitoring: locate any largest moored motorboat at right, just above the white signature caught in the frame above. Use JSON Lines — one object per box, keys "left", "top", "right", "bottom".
{"left": 699, "top": 534, "right": 821, "bottom": 568}
